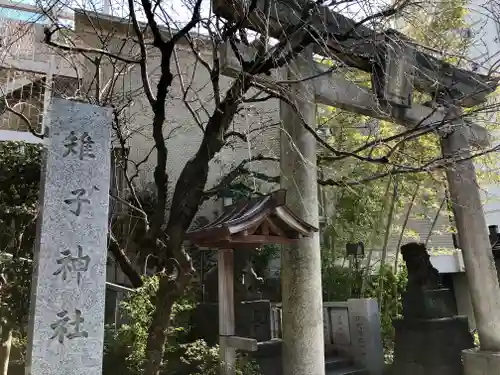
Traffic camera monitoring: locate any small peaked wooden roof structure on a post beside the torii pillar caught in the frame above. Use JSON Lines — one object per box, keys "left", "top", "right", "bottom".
{"left": 186, "top": 190, "right": 318, "bottom": 375}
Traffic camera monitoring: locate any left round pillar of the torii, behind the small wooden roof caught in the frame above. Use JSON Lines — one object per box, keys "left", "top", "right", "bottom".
{"left": 280, "top": 50, "right": 325, "bottom": 375}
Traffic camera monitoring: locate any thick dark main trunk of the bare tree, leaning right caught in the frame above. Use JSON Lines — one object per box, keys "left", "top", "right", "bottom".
{"left": 144, "top": 78, "right": 250, "bottom": 375}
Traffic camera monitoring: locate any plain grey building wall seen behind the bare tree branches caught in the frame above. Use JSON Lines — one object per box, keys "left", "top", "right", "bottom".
{"left": 76, "top": 12, "right": 279, "bottom": 223}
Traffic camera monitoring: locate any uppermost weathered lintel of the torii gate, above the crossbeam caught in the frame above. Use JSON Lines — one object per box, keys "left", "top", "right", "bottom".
{"left": 213, "top": 0, "right": 498, "bottom": 107}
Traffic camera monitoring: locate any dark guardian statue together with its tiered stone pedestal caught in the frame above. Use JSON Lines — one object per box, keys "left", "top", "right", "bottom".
{"left": 393, "top": 243, "right": 474, "bottom": 375}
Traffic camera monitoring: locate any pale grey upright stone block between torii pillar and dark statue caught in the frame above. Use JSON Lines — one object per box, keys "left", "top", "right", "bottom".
{"left": 347, "top": 298, "right": 384, "bottom": 375}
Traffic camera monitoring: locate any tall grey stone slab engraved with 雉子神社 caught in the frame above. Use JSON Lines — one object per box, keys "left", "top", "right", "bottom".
{"left": 26, "top": 99, "right": 111, "bottom": 375}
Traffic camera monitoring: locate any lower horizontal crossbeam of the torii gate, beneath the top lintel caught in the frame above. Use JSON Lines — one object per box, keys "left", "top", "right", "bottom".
{"left": 220, "top": 44, "right": 490, "bottom": 148}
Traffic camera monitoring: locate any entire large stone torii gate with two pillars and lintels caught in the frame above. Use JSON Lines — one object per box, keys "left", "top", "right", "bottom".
{"left": 214, "top": 0, "right": 500, "bottom": 375}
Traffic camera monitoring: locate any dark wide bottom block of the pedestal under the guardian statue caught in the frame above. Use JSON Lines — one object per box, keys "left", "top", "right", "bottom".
{"left": 392, "top": 316, "right": 472, "bottom": 375}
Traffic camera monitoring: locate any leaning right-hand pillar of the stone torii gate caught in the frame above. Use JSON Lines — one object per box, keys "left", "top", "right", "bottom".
{"left": 441, "top": 120, "right": 500, "bottom": 352}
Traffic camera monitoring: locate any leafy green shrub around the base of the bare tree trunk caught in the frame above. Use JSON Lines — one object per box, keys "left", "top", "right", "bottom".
{"left": 103, "top": 276, "right": 258, "bottom": 375}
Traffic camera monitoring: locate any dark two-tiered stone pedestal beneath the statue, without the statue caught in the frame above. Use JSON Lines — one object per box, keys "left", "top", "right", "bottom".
{"left": 393, "top": 289, "right": 474, "bottom": 375}
